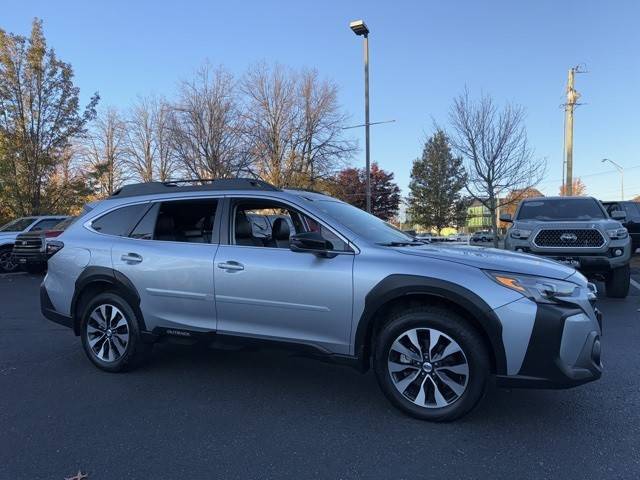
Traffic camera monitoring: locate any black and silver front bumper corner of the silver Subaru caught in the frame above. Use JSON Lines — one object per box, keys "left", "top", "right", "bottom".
{"left": 497, "top": 304, "right": 602, "bottom": 388}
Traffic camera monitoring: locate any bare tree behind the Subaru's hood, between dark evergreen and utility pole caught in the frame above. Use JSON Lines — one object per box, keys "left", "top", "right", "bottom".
{"left": 450, "top": 91, "right": 546, "bottom": 247}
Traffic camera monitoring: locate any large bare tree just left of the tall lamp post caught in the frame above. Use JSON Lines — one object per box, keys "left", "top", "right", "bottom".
{"left": 243, "top": 64, "right": 356, "bottom": 186}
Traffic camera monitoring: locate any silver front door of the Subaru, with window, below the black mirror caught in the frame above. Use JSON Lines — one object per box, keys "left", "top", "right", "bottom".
{"left": 214, "top": 199, "right": 354, "bottom": 354}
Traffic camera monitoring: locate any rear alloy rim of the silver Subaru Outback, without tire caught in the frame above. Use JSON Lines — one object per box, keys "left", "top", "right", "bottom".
{"left": 86, "top": 304, "right": 129, "bottom": 363}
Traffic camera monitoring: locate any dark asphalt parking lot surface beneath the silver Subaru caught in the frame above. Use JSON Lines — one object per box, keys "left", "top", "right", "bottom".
{"left": 0, "top": 270, "right": 640, "bottom": 480}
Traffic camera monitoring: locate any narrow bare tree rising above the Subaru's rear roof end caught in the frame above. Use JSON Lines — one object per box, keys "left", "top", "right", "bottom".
{"left": 125, "top": 97, "right": 173, "bottom": 182}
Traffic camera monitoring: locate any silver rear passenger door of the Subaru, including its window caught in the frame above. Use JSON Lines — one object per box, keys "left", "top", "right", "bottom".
{"left": 111, "top": 198, "right": 220, "bottom": 331}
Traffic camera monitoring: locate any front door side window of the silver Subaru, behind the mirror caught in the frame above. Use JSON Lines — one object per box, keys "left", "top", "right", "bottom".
{"left": 232, "top": 200, "right": 349, "bottom": 251}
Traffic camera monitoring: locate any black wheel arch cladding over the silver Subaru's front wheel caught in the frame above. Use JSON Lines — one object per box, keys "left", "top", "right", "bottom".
{"left": 355, "top": 274, "right": 507, "bottom": 374}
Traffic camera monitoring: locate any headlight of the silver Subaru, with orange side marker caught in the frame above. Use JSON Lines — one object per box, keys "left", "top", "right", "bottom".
{"left": 486, "top": 271, "right": 578, "bottom": 303}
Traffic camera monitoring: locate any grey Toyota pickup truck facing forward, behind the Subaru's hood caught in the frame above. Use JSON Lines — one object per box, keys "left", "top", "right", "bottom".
{"left": 500, "top": 197, "right": 631, "bottom": 298}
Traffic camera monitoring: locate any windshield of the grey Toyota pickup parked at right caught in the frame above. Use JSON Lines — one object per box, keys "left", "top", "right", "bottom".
{"left": 517, "top": 198, "right": 605, "bottom": 222}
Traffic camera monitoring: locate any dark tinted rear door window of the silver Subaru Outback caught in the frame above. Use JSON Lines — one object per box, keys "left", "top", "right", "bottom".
{"left": 152, "top": 198, "right": 218, "bottom": 243}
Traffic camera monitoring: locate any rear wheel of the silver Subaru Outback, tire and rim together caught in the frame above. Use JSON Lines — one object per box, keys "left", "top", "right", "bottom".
{"left": 80, "top": 292, "right": 152, "bottom": 372}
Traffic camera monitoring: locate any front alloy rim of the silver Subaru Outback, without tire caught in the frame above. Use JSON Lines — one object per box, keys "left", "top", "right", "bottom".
{"left": 387, "top": 328, "right": 469, "bottom": 408}
